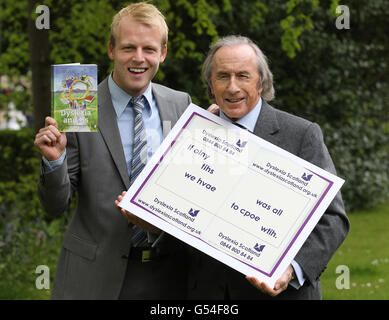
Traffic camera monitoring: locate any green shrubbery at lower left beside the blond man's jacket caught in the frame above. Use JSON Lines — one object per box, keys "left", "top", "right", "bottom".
{"left": 0, "top": 129, "right": 68, "bottom": 299}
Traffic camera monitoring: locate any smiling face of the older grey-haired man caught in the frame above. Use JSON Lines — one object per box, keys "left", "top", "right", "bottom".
{"left": 211, "top": 44, "right": 263, "bottom": 121}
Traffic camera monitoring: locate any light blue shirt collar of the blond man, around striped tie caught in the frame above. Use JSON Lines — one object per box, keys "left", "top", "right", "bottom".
{"left": 108, "top": 73, "right": 153, "bottom": 118}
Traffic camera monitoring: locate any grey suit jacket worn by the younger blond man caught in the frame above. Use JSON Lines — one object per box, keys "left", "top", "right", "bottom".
{"left": 38, "top": 79, "right": 191, "bottom": 299}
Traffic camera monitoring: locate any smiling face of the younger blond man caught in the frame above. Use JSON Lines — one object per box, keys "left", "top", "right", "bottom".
{"left": 108, "top": 18, "right": 167, "bottom": 97}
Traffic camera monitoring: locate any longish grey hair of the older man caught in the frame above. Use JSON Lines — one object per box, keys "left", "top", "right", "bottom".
{"left": 202, "top": 35, "right": 275, "bottom": 101}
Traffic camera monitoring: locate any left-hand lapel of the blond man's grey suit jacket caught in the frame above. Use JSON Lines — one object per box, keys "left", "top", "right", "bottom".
{"left": 98, "top": 78, "right": 130, "bottom": 189}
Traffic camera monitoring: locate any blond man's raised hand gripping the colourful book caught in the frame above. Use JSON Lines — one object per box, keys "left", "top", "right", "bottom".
{"left": 34, "top": 117, "right": 67, "bottom": 161}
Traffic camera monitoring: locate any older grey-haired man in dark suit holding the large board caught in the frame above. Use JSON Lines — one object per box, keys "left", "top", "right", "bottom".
{"left": 189, "top": 36, "right": 349, "bottom": 299}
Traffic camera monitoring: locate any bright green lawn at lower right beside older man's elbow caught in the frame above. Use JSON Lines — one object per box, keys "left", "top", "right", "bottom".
{"left": 321, "top": 202, "right": 389, "bottom": 300}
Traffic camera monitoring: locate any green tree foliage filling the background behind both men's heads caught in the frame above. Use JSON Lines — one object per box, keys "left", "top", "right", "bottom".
{"left": 0, "top": 0, "right": 389, "bottom": 209}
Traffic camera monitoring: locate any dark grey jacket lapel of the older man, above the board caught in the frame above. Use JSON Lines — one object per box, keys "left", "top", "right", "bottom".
{"left": 254, "top": 100, "right": 280, "bottom": 145}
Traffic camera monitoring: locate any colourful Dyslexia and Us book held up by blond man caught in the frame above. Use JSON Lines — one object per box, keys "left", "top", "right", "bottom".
{"left": 51, "top": 63, "right": 98, "bottom": 132}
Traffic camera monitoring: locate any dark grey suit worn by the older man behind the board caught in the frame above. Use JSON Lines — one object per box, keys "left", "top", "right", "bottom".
{"left": 189, "top": 101, "right": 349, "bottom": 299}
